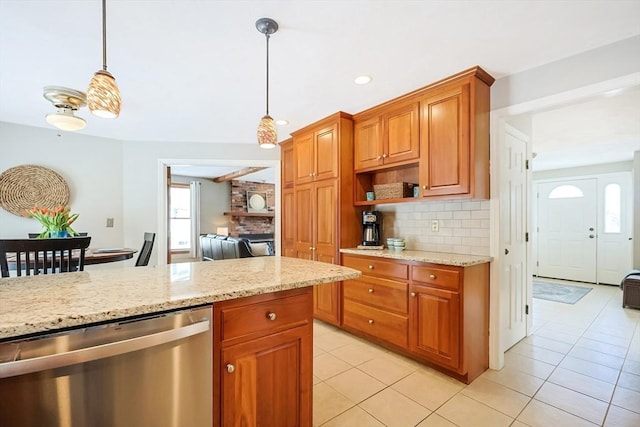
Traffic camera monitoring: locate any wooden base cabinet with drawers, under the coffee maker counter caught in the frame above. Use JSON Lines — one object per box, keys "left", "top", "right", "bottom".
{"left": 341, "top": 254, "right": 489, "bottom": 383}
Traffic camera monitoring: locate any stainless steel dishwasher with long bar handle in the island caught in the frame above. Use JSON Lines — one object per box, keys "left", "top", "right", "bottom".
{"left": 0, "top": 307, "right": 213, "bottom": 427}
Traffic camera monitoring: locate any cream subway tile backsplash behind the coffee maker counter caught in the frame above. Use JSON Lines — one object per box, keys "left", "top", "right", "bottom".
{"left": 375, "top": 200, "right": 490, "bottom": 255}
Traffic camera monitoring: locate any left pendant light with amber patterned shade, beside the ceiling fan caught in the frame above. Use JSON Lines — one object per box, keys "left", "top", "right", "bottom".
{"left": 87, "top": 0, "right": 122, "bottom": 119}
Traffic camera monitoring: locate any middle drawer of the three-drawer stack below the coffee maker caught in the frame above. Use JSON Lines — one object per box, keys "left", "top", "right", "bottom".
{"left": 342, "top": 276, "right": 407, "bottom": 314}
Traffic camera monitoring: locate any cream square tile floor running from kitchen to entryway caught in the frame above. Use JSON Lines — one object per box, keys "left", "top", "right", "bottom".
{"left": 313, "top": 285, "right": 640, "bottom": 427}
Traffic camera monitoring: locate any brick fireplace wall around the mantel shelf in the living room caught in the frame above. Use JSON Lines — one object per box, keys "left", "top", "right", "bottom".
{"left": 229, "top": 180, "right": 276, "bottom": 236}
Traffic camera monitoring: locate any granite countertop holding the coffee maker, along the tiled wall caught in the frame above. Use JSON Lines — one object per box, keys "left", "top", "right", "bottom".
{"left": 340, "top": 248, "right": 493, "bottom": 267}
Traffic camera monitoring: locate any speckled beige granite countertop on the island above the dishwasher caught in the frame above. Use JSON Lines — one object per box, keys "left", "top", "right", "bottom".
{"left": 0, "top": 256, "right": 361, "bottom": 339}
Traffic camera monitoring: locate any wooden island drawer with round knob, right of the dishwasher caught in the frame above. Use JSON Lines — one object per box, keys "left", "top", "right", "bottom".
{"left": 220, "top": 292, "right": 313, "bottom": 342}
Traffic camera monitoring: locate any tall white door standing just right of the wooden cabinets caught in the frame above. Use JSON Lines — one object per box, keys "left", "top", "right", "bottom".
{"left": 500, "top": 124, "right": 529, "bottom": 351}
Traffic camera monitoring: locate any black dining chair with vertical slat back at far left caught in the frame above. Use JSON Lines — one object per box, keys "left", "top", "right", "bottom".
{"left": 0, "top": 237, "right": 91, "bottom": 277}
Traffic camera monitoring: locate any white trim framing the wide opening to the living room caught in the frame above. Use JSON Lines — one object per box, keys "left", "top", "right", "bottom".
{"left": 156, "top": 159, "right": 281, "bottom": 265}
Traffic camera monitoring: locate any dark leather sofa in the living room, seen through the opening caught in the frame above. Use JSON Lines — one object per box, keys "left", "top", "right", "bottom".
{"left": 200, "top": 234, "right": 273, "bottom": 261}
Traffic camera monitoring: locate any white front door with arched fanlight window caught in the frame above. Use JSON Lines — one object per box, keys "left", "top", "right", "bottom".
{"left": 537, "top": 178, "right": 598, "bottom": 283}
